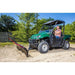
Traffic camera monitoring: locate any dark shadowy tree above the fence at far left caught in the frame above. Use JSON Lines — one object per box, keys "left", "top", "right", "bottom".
{"left": 0, "top": 15, "right": 16, "bottom": 32}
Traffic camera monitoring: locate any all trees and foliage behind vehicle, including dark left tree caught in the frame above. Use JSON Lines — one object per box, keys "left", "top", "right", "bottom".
{"left": 0, "top": 13, "right": 75, "bottom": 42}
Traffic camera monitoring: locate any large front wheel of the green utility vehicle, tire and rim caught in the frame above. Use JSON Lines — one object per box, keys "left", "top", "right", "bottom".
{"left": 38, "top": 41, "right": 49, "bottom": 53}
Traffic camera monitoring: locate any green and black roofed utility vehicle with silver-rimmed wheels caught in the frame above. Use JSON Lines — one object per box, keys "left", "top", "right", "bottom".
{"left": 29, "top": 20, "right": 71, "bottom": 53}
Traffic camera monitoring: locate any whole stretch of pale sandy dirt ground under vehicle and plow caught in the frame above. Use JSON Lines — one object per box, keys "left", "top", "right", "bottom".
{"left": 0, "top": 44, "right": 75, "bottom": 62}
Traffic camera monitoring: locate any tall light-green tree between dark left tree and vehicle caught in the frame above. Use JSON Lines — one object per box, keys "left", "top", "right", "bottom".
{"left": 13, "top": 13, "right": 38, "bottom": 42}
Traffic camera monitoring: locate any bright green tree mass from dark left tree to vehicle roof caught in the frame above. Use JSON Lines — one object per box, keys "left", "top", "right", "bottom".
{"left": 12, "top": 13, "right": 54, "bottom": 42}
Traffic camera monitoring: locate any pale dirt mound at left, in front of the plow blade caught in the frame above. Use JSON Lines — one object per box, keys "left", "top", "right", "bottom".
{"left": 0, "top": 45, "right": 26, "bottom": 61}
